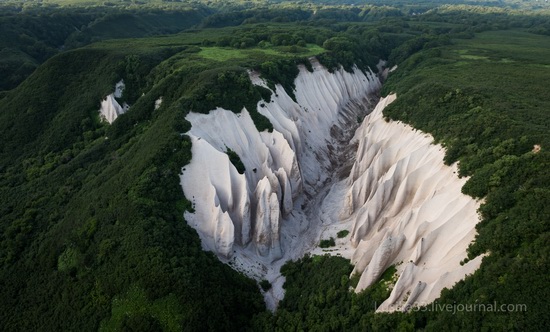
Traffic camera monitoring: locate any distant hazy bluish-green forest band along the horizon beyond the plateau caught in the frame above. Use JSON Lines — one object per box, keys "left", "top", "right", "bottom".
{"left": 0, "top": 1, "right": 549, "bottom": 91}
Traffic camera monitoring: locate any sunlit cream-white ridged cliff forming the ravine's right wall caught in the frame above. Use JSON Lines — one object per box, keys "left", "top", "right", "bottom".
{"left": 325, "top": 95, "right": 481, "bottom": 311}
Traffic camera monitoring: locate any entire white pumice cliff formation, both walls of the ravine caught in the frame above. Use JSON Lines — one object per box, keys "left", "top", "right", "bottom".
{"left": 181, "top": 61, "right": 481, "bottom": 311}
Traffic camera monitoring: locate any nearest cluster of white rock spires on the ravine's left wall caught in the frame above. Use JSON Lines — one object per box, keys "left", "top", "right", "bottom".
{"left": 182, "top": 109, "right": 301, "bottom": 261}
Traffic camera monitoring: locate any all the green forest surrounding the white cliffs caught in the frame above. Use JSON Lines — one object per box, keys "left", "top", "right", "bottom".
{"left": 0, "top": 0, "right": 550, "bottom": 331}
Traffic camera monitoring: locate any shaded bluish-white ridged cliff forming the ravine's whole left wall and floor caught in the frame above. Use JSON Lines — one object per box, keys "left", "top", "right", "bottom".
{"left": 181, "top": 61, "right": 380, "bottom": 308}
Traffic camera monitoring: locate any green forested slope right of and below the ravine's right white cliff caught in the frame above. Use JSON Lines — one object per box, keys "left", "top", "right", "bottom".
{"left": 252, "top": 24, "right": 550, "bottom": 331}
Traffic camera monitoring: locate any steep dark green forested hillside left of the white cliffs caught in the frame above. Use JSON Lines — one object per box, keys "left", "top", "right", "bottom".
{"left": 0, "top": 39, "right": 263, "bottom": 331}
